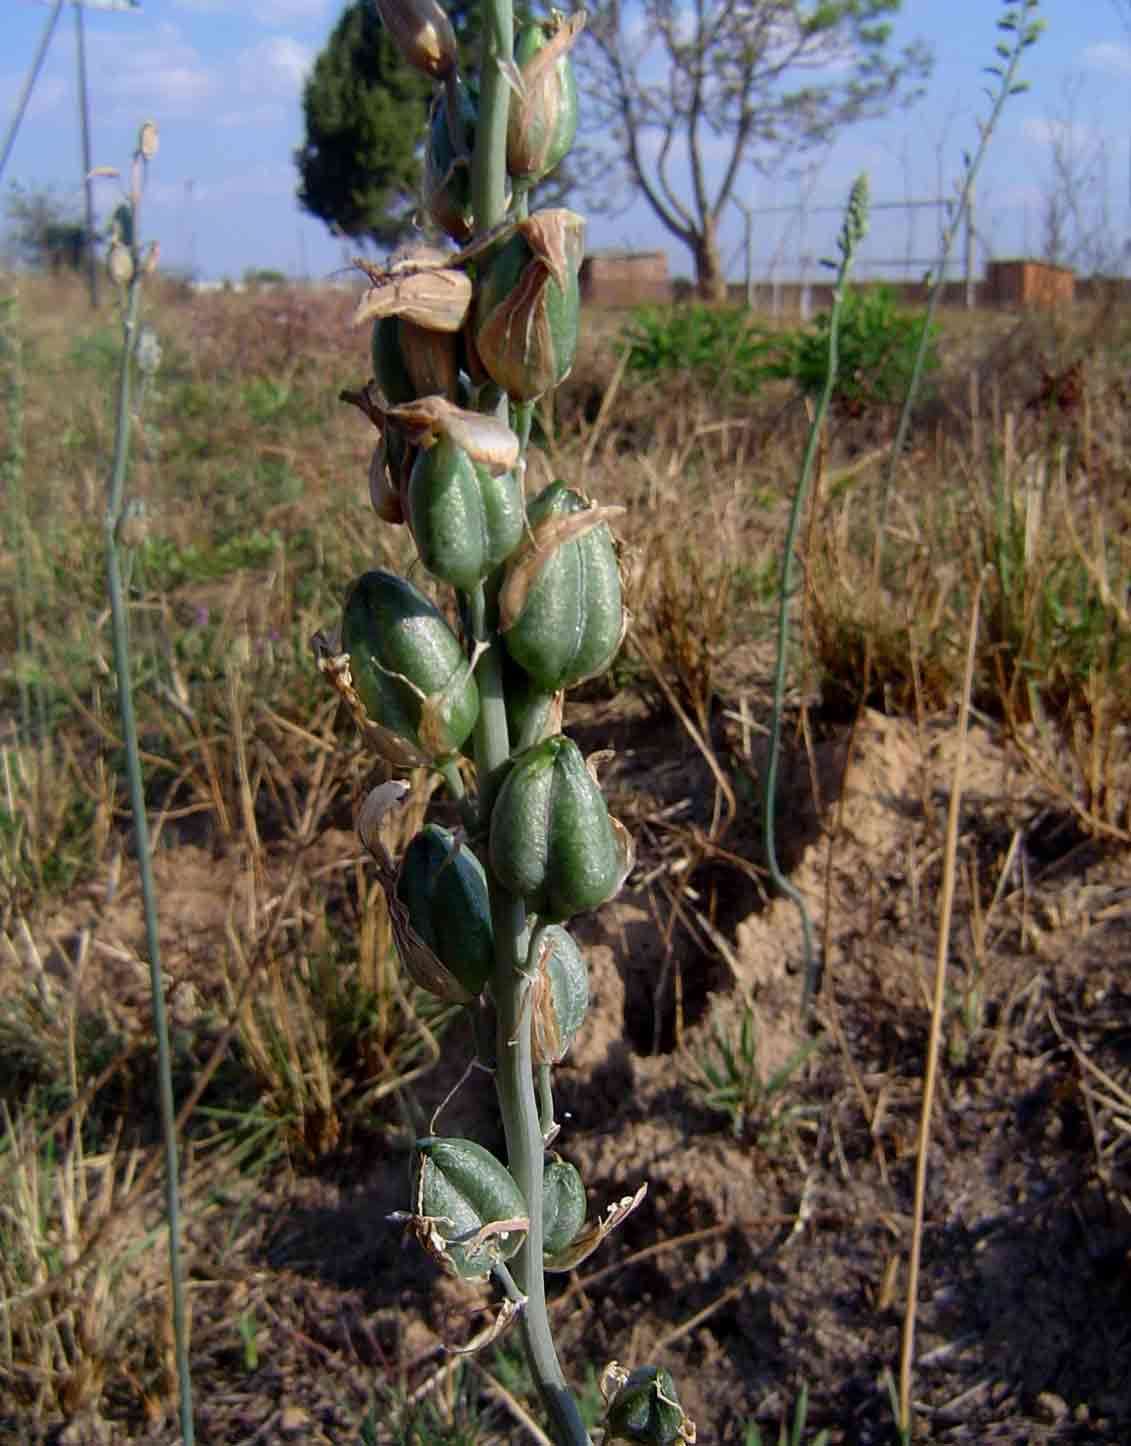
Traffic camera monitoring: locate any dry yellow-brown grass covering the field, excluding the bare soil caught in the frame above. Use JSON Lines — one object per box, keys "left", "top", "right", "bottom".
{"left": 0, "top": 281, "right": 1131, "bottom": 1446}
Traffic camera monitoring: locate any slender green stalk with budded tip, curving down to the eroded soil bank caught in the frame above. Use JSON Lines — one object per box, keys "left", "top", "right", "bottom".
{"left": 762, "top": 179, "right": 866, "bottom": 1019}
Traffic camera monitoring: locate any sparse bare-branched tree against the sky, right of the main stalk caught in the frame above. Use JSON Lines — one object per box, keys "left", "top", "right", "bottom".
{"left": 579, "top": 0, "right": 930, "bottom": 301}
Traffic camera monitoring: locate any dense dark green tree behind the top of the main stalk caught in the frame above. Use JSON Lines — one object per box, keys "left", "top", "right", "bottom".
{"left": 295, "top": 0, "right": 432, "bottom": 246}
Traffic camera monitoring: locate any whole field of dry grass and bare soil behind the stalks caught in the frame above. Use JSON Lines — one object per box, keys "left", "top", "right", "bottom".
{"left": 0, "top": 268, "right": 1131, "bottom": 1446}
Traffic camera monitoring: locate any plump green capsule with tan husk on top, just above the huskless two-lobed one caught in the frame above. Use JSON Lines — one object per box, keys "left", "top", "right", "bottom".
{"left": 502, "top": 482, "right": 625, "bottom": 693}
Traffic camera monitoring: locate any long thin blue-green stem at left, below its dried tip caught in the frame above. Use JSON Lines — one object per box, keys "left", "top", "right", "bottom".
{"left": 103, "top": 210, "right": 195, "bottom": 1446}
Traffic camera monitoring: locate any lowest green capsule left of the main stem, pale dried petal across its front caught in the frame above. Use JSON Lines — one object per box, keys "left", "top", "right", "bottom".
{"left": 412, "top": 1137, "right": 529, "bottom": 1280}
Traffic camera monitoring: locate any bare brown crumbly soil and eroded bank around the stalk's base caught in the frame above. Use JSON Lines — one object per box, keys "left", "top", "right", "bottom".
{"left": 8, "top": 682, "right": 1131, "bottom": 1446}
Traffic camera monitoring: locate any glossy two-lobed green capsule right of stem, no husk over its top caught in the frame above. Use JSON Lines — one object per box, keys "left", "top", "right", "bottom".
{"left": 489, "top": 735, "right": 632, "bottom": 923}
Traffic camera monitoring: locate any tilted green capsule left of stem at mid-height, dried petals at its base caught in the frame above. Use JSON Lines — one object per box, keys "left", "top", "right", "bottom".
{"left": 341, "top": 570, "right": 479, "bottom": 759}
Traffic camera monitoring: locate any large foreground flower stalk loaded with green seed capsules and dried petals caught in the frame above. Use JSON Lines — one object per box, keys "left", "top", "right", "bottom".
{"left": 314, "top": 0, "right": 694, "bottom": 1443}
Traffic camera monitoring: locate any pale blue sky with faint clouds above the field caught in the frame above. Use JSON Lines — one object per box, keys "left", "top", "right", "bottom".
{"left": 0, "top": 0, "right": 1131, "bottom": 278}
